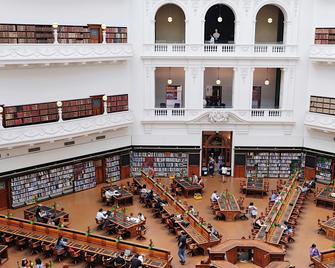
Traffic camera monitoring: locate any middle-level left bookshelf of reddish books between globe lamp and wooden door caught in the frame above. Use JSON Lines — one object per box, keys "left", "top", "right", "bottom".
{"left": 62, "top": 98, "right": 93, "bottom": 120}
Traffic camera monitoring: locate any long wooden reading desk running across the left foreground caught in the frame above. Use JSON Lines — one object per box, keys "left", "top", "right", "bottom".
{"left": 0, "top": 215, "right": 172, "bottom": 268}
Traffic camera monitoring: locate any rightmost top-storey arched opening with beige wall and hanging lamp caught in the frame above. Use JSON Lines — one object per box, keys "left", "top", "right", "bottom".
{"left": 255, "top": 5, "right": 284, "bottom": 44}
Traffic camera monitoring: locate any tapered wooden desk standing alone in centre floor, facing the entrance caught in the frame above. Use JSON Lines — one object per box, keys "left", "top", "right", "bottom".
{"left": 218, "top": 192, "right": 241, "bottom": 221}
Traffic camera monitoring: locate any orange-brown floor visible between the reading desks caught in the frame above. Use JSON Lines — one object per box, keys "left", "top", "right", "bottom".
{"left": 1, "top": 177, "right": 334, "bottom": 268}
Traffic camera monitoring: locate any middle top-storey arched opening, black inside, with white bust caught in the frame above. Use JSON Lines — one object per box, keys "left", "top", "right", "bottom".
{"left": 204, "top": 4, "right": 235, "bottom": 44}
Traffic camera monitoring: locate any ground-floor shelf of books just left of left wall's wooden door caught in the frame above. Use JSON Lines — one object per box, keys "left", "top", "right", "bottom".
{"left": 74, "top": 161, "right": 96, "bottom": 192}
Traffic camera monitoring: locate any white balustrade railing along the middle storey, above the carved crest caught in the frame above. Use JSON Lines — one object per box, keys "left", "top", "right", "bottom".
{"left": 143, "top": 108, "right": 293, "bottom": 122}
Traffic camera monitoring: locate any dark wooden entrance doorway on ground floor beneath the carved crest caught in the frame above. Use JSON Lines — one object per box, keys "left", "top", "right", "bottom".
{"left": 202, "top": 131, "right": 232, "bottom": 168}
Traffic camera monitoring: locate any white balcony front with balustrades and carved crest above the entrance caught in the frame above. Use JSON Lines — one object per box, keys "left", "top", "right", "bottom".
{"left": 143, "top": 108, "right": 294, "bottom": 125}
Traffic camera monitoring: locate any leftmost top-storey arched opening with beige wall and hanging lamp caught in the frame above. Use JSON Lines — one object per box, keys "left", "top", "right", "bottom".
{"left": 155, "top": 4, "right": 185, "bottom": 43}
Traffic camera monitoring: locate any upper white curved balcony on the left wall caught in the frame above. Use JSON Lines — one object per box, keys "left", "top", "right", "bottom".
{"left": 0, "top": 44, "right": 133, "bottom": 67}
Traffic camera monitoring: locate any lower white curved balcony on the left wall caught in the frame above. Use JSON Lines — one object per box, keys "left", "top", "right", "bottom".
{"left": 0, "top": 112, "right": 133, "bottom": 148}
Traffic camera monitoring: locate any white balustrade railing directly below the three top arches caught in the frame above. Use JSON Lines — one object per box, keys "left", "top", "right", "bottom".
{"left": 143, "top": 43, "right": 297, "bottom": 58}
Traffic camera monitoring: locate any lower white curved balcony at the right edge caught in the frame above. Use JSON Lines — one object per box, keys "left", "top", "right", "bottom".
{"left": 304, "top": 112, "right": 335, "bottom": 133}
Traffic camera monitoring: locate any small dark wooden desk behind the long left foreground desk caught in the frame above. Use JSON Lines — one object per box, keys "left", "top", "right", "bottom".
{"left": 23, "top": 205, "right": 70, "bottom": 225}
